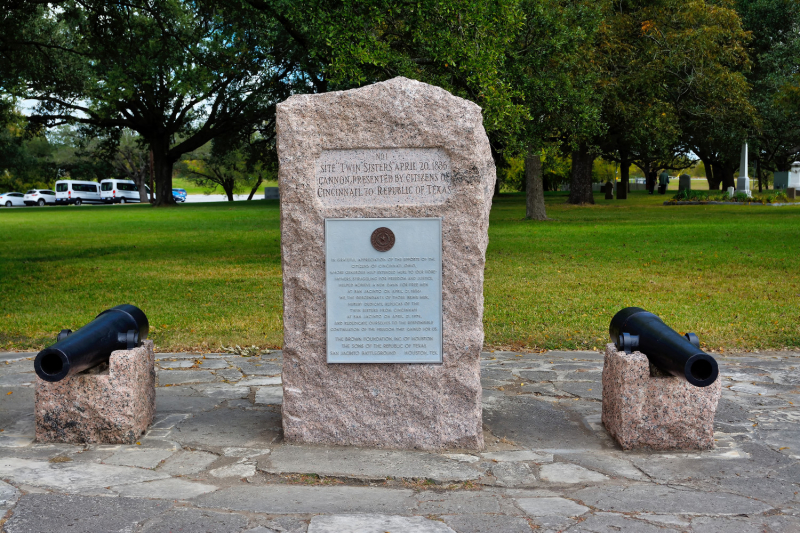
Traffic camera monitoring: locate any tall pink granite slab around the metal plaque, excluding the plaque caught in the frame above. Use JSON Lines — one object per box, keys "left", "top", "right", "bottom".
{"left": 277, "top": 78, "right": 496, "bottom": 450}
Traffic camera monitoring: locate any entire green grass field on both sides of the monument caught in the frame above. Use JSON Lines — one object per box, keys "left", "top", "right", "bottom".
{"left": 0, "top": 192, "right": 800, "bottom": 351}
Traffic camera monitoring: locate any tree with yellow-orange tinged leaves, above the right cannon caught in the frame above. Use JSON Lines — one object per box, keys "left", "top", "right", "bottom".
{"left": 597, "top": 0, "right": 753, "bottom": 193}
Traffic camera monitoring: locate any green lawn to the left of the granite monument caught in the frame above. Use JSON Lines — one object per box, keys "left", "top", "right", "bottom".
{"left": 0, "top": 200, "right": 282, "bottom": 350}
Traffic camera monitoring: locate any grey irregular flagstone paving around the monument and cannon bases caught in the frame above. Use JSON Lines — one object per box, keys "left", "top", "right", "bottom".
{"left": 0, "top": 352, "right": 800, "bottom": 533}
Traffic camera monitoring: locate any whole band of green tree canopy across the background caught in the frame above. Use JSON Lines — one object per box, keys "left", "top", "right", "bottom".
{"left": 0, "top": 0, "right": 800, "bottom": 201}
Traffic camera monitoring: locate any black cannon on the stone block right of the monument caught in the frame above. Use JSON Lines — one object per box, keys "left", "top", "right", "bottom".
{"left": 608, "top": 307, "right": 719, "bottom": 387}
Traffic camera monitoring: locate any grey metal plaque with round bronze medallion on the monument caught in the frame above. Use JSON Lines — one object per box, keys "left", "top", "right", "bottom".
{"left": 325, "top": 218, "right": 442, "bottom": 363}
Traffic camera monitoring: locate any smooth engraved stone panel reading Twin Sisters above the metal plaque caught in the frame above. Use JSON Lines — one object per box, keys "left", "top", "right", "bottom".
{"left": 314, "top": 148, "right": 451, "bottom": 207}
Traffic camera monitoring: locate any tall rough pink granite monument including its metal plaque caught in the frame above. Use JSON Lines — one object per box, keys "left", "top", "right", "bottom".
{"left": 277, "top": 78, "right": 496, "bottom": 450}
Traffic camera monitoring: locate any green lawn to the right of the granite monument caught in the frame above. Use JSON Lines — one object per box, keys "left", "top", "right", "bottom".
{"left": 484, "top": 191, "right": 800, "bottom": 350}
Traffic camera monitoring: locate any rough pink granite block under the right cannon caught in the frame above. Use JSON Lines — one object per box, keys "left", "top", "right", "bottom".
{"left": 603, "top": 344, "right": 722, "bottom": 450}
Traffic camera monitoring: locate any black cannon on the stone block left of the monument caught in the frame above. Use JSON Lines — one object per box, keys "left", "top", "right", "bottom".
{"left": 33, "top": 304, "right": 150, "bottom": 381}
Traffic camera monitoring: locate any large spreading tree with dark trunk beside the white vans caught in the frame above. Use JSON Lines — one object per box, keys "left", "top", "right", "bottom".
{"left": 0, "top": 0, "right": 294, "bottom": 205}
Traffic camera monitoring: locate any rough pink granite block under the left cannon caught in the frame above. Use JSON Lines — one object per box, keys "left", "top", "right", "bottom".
{"left": 35, "top": 340, "right": 156, "bottom": 444}
